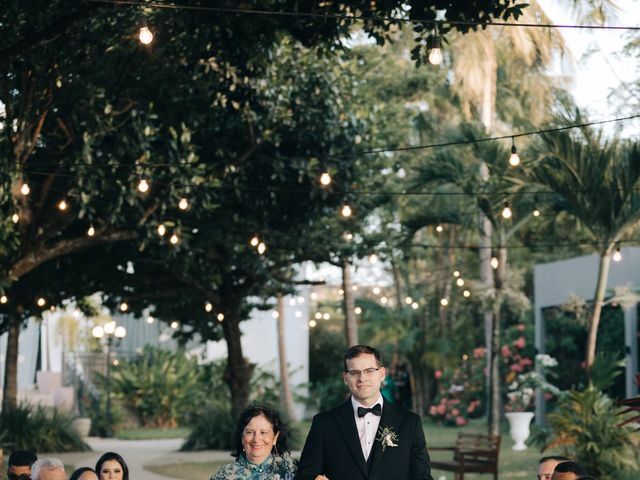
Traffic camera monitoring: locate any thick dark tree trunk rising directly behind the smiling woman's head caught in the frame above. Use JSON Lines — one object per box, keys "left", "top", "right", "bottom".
{"left": 222, "top": 299, "right": 255, "bottom": 418}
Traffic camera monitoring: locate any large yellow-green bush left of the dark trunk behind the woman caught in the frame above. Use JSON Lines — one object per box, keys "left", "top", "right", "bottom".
{"left": 111, "top": 346, "right": 201, "bottom": 428}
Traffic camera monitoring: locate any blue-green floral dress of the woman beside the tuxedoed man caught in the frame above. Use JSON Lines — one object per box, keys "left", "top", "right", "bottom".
{"left": 211, "top": 453, "right": 298, "bottom": 480}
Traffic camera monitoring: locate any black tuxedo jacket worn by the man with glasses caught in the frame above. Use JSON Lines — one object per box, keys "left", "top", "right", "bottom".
{"left": 296, "top": 399, "right": 433, "bottom": 480}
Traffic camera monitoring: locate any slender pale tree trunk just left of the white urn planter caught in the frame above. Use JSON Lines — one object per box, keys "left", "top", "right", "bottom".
{"left": 489, "top": 247, "right": 507, "bottom": 435}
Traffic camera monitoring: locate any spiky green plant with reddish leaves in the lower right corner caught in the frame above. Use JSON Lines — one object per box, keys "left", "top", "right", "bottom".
{"left": 530, "top": 386, "right": 639, "bottom": 480}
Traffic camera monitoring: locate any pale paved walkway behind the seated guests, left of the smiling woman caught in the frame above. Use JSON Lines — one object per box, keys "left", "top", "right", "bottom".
{"left": 52, "top": 437, "right": 233, "bottom": 480}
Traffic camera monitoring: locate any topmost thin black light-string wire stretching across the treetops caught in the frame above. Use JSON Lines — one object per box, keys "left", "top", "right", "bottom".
{"left": 86, "top": 0, "right": 640, "bottom": 31}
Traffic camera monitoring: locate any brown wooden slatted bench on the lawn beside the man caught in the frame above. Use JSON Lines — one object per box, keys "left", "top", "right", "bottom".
{"left": 429, "top": 433, "right": 500, "bottom": 480}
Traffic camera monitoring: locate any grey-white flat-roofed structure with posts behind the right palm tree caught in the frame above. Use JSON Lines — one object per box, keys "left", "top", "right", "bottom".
{"left": 534, "top": 247, "right": 640, "bottom": 422}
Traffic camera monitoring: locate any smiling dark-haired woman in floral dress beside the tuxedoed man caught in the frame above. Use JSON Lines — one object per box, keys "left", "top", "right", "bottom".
{"left": 211, "top": 405, "right": 297, "bottom": 480}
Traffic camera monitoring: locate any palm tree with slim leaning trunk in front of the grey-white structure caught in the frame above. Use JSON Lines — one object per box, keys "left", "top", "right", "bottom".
{"left": 525, "top": 118, "right": 640, "bottom": 370}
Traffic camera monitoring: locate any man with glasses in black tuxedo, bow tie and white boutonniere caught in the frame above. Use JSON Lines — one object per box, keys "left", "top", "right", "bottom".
{"left": 296, "top": 345, "right": 433, "bottom": 480}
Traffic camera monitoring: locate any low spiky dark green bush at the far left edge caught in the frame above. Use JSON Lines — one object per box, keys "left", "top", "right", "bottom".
{"left": 0, "top": 404, "right": 90, "bottom": 452}
